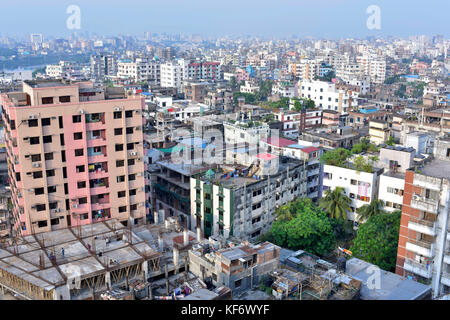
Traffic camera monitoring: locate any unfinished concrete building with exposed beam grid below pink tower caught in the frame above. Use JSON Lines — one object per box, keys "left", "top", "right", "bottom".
{"left": 0, "top": 220, "right": 201, "bottom": 300}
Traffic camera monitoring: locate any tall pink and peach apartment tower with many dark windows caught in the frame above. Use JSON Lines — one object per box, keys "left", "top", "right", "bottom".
{"left": 1, "top": 80, "right": 146, "bottom": 235}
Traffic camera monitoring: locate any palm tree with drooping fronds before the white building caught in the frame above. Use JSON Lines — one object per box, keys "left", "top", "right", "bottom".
{"left": 319, "top": 187, "right": 352, "bottom": 220}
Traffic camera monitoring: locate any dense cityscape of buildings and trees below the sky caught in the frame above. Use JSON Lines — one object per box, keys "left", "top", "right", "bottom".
{"left": 0, "top": 1, "right": 450, "bottom": 308}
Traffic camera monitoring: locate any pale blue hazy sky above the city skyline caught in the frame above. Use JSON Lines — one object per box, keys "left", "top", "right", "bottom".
{"left": 0, "top": 0, "right": 450, "bottom": 38}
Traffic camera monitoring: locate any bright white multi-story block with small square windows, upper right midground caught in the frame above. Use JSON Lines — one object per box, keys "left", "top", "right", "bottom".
{"left": 299, "top": 81, "right": 359, "bottom": 115}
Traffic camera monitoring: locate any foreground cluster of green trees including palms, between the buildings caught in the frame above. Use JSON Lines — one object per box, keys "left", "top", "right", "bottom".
{"left": 261, "top": 187, "right": 401, "bottom": 271}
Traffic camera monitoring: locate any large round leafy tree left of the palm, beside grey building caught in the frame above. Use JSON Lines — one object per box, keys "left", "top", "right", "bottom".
{"left": 263, "top": 199, "right": 336, "bottom": 256}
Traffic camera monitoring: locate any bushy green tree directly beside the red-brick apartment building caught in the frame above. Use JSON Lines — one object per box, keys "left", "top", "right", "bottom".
{"left": 350, "top": 211, "right": 401, "bottom": 271}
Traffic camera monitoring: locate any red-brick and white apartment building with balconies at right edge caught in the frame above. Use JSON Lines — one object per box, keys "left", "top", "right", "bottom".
{"left": 396, "top": 137, "right": 450, "bottom": 297}
